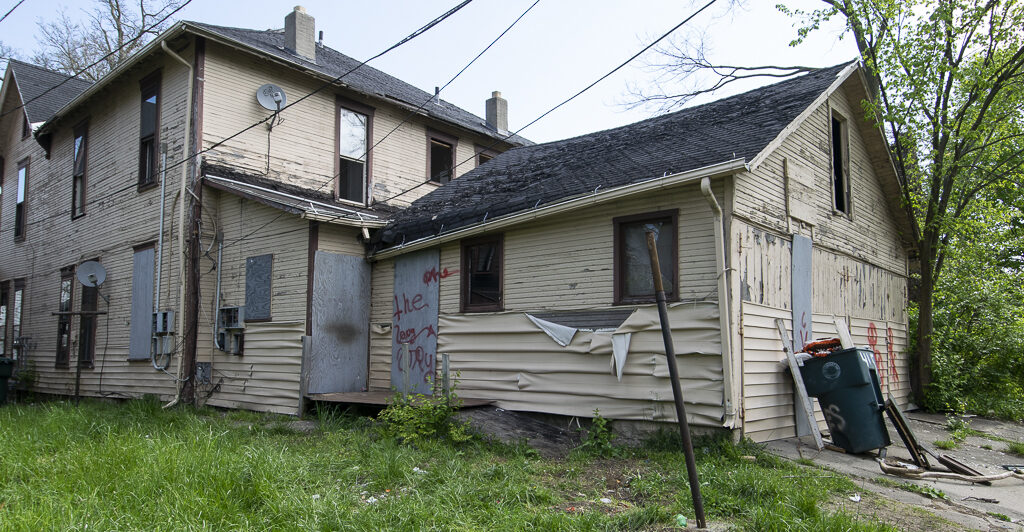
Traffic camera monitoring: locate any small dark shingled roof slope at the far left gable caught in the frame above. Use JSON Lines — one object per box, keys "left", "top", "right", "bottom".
{"left": 7, "top": 59, "right": 92, "bottom": 124}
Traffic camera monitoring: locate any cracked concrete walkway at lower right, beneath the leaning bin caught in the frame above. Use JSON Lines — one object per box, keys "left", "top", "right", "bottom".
{"left": 766, "top": 412, "right": 1024, "bottom": 531}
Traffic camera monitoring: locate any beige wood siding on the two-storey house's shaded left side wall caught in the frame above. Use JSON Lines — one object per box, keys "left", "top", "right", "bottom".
{"left": 0, "top": 46, "right": 193, "bottom": 398}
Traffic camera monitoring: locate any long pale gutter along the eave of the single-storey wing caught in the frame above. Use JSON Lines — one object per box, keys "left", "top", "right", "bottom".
{"left": 370, "top": 159, "right": 748, "bottom": 261}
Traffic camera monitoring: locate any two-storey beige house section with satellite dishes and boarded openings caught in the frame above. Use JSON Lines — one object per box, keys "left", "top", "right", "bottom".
{"left": 0, "top": 7, "right": 528, "bottom": 413}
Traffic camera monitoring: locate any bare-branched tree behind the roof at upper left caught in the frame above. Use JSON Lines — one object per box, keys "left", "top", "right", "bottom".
{"left": 31, "top": 0, "right": 182, "bottom": 81}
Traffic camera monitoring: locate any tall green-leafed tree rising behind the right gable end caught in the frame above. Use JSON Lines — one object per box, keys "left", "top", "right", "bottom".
{"left": 630, "top": 0, "right": 1024, "bottom": 401}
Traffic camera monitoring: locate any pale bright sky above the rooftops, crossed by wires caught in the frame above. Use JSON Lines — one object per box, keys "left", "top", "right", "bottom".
{"left": 0, "top": 0, "right": 857, "bottom": 142}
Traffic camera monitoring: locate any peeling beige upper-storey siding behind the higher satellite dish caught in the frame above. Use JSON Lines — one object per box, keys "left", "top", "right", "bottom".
{"left": 203, "top": 42, "right": 503, "bottom": 205}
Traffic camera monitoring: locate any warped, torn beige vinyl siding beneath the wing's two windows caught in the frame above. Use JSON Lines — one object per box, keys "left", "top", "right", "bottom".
{"left": 437, "top": 303, "right": 724, "bottom": 427}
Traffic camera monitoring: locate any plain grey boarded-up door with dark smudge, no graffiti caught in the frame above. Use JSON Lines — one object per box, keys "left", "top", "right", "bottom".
{"left": 306, "top": 252, "right": 370, "bottom": 394}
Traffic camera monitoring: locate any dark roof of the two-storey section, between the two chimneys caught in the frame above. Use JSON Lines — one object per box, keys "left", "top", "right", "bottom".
{"left": 184, "top": 21, "right": 532, "bottom": 145}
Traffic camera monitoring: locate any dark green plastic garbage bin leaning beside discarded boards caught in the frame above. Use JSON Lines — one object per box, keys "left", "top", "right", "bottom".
{"left": 800, "top": 348, "right": 892, "bottom": 453}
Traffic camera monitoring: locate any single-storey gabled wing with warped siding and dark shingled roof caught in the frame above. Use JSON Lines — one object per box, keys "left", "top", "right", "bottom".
{"left": 369, "top": 63, "right": 910, "bottom": 440}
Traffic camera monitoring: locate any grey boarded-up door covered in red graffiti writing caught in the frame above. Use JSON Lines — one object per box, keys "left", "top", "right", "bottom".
{"left": 391, "top": 250, "right": 442, "bottom": 395}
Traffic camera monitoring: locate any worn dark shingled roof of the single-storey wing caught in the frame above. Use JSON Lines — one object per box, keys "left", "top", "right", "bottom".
{"left": 380, "top": 63, "right": 849, "bottom": 248}
